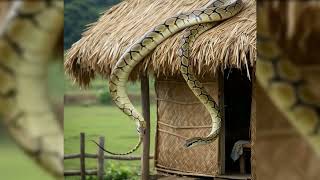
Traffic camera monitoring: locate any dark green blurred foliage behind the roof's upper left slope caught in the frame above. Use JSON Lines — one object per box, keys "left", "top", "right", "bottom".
{"left": 64, "top": 0, "right": 119, "bottom": 49}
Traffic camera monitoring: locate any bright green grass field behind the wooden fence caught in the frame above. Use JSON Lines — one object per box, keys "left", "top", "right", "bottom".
{"left": 64, "top": 105, "right": 156, "bottom": 177}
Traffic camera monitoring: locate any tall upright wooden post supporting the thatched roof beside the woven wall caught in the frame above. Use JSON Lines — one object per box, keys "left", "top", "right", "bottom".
{"left": 141, "top": 75, "right": 150, "bottom": 180}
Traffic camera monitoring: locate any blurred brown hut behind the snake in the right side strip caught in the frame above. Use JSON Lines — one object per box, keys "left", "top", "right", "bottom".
{"left": 253, "top": 1, "right": 320, "bottom": 180}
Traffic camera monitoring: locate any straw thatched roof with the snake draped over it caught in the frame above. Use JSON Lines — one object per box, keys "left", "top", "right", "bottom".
{"left": 65, "top": 0, "right": 256, "bottom": 86}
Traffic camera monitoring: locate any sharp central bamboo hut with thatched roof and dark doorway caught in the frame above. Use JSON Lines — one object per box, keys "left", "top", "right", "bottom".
{"left": 65, "top": 0, "right": 256, "bottom": 179}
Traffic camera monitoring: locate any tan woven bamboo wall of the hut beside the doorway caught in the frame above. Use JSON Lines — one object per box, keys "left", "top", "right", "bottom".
{"left": 155, "top": 76, "right": 219, "bottom": 176}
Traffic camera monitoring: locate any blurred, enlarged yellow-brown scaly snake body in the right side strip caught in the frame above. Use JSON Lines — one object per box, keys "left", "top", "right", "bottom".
{"left": 256, "top": 4, "right": 320, "bottom": 154}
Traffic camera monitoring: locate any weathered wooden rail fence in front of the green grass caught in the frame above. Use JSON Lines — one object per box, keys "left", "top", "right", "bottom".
{"left": 64, "top": 133, "right": 153, "bottom": 180}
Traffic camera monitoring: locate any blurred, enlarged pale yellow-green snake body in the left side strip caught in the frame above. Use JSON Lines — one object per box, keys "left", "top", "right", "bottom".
{"left": 0, "top": 0, "right": 63, "bottom": 177}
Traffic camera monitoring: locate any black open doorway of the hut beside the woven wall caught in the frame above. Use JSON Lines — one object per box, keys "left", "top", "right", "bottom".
{"left": 224, "top": 68, "right": 252, "bottom": 174}
